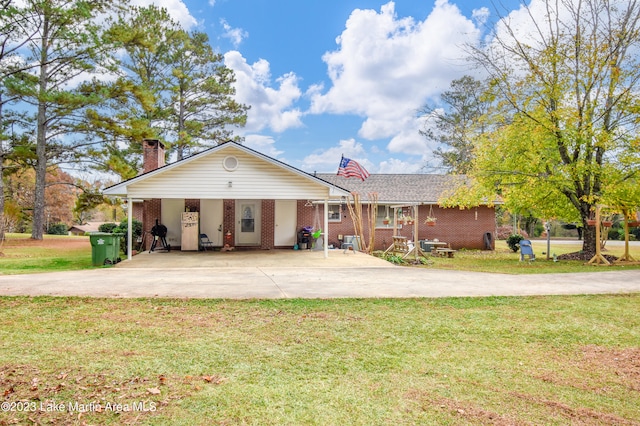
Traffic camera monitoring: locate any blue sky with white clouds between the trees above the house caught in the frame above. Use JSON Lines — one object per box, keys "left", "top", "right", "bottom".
{"left": 133, "top": 0, "right": 519, "bottom": 173}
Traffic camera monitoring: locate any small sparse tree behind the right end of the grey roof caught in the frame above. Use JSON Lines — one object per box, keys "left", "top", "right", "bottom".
{"left": 420, "top": 75, "right": 489, "bottom": 174}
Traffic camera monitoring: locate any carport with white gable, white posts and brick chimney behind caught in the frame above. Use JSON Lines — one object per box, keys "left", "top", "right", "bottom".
{"left": 103, "top": 140, "right": 350, "bottom": 259}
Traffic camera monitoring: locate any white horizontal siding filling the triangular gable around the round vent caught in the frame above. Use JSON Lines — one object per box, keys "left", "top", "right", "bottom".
{"left": 128, "top": 147, "right": 336, "bottom": 200}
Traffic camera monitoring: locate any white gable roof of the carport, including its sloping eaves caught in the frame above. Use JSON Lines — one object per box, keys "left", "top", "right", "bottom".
{"left": 103, "top": 141, "right": 349, "bottom": 199}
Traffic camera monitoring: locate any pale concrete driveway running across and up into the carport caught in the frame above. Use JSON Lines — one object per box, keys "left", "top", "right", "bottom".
{"left": 0, "top": 250, "right": 640, "bottom": 299}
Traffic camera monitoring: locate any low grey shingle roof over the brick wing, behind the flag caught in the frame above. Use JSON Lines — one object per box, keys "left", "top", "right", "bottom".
{"left": 317, "top": 173, "right": 467, "bottom": 204}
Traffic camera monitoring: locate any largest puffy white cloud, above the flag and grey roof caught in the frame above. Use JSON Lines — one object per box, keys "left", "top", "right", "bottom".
{"left": 309, "top": 0, "right": 486, "bottom": 154}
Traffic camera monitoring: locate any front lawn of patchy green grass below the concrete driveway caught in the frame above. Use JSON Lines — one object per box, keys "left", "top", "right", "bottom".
{"left": 0, "top": 295, "right": 640, "bottom": 425}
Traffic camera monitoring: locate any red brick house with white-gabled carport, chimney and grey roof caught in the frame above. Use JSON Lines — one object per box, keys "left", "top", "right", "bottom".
{"left": 104, "top": 140, "right": 495, "bottom": 253}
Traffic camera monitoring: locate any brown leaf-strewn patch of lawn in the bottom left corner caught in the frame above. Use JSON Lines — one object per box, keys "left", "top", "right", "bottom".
{"left": 0, "top": 365, "right": 226, "bottom": 426}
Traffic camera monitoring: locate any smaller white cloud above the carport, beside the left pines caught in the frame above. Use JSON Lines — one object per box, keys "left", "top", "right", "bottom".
{"left": 224, "top": 51, "right": 302, "bottom": 133}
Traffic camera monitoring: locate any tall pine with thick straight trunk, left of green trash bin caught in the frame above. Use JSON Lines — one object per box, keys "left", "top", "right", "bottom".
{"left": 4, "top": 0, "right": 125, "bottom": 239}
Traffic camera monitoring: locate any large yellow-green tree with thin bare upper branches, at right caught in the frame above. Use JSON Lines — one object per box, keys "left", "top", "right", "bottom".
{"left": 459, "top": 0, "right": 640, "bottom": 253}
